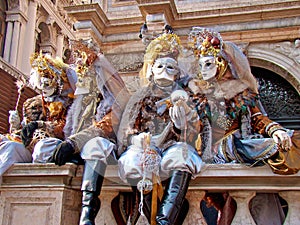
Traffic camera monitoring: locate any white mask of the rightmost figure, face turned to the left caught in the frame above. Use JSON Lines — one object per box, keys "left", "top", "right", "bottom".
{"left": 199, "top": 56, "right": 218, "bottom": 80}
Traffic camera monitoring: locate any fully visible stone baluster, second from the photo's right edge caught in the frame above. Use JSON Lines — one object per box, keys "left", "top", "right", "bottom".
{"left": 229, "top": 191, "right": 256, "bottom": 225}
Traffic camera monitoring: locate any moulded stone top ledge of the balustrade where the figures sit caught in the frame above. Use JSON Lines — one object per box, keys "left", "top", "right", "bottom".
{"left": 0, "top": 163, "right": 300, "bottom": 192}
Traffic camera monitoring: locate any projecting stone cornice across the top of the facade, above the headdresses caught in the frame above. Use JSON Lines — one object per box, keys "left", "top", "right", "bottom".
{"left": 65, "top": 0, "right": 300, "bottom": 42}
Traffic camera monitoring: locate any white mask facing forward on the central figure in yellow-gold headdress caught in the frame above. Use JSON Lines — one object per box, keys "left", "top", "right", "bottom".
{"left": 152, "top": 57, "right": 179, "bottom": 87}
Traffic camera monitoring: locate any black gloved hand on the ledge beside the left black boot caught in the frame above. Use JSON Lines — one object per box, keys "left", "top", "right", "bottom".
{"left": 52, "top": 141, "right": 75, "bottom": 166}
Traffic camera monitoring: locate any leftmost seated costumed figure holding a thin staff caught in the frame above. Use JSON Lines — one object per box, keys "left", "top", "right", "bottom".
{"left": 0, "top": 53, "right": 76, "bottom": 179}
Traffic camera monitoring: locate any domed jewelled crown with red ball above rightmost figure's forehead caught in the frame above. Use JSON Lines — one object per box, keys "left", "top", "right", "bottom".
{"left": 188, "top": 27, "right": 223, "bottom": 57}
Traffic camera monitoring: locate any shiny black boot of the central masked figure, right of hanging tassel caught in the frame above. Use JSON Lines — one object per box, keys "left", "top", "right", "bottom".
{"left": 156, "top": 171, "right": 191, "bottom": 225}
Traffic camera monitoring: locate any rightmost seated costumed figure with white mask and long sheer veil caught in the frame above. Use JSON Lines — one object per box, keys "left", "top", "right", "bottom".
{"left": 189, "top": 27, "right": 300, "bottom": 224}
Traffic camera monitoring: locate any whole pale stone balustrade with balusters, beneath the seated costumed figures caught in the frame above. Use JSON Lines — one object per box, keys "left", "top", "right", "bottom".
{"left": 0, "top": 163, "right": 300, "bottom": 225}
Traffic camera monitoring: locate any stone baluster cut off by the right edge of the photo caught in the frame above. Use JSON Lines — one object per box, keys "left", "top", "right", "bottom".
{"left": 279, "top": 191, "right": 300, "bottom": 225}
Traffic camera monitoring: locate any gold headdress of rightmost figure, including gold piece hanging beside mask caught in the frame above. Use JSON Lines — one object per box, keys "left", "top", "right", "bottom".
{"left": 188, "top": 27, "right": 228, "bottom": 79}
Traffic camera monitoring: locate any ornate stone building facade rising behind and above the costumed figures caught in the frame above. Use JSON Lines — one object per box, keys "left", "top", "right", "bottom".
{"left": 0, "top": 0, "right": 300, "bottom": 132}
